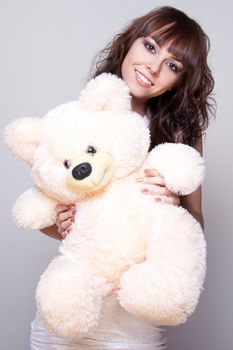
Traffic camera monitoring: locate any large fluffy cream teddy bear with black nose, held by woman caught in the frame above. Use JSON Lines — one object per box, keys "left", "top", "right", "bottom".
{"left": 6, "top": 73, "right": 206, "bottom": 338}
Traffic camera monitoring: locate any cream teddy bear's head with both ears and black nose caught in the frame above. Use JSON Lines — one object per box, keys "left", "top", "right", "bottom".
{"left": 6, "top": 73, "right": 150, "bottom": 204}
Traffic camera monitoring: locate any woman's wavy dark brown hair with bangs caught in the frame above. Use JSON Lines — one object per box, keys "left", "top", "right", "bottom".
{"left": 88, "top": 6, "right": 215, "bottom": 148}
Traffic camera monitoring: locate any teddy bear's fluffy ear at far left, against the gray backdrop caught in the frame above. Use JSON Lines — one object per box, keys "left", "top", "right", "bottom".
{"left": 4, "top": 117, "right": 42, "bottom": 164}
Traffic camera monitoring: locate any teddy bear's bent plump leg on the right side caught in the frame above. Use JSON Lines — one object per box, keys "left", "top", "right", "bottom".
{"left": 118, "top": 210, "right": 205, "bottom": 325}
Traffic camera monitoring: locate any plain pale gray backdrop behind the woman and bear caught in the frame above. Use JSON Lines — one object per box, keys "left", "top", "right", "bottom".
{"left": 0, "top": 0, "right": 233, "bottom": 350}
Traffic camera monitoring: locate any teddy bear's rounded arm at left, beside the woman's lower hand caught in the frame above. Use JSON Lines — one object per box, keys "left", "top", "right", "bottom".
{"left": 13, "top": 187, "right": 58, "bottom": 230}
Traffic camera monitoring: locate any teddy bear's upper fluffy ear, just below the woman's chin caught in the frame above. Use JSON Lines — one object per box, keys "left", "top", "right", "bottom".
{"left": 79, "top": 73, "right": 131, "bottom": 112}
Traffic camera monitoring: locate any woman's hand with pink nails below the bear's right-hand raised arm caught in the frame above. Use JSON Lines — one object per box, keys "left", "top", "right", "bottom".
{"left": 136, "top": 169, "right": 180, "bottom": 205}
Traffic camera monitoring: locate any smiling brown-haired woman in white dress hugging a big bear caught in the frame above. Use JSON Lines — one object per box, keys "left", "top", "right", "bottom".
{"left": 31, "top": 7, "right": 214, "bottom": 350}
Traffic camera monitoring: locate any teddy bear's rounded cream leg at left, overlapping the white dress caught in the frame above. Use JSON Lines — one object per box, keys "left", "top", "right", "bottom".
{"left": 36, "top": 256, "right": 102, "bottom": 338}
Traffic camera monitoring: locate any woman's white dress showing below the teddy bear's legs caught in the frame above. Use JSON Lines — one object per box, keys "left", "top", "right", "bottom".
{"left": 31, "top": 295, "right": 166, "bottom": 350}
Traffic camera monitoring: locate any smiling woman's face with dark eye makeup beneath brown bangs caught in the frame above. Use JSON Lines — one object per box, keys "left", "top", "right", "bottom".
{"left": 121, "top": 36, "right": 183, "bottom": 103}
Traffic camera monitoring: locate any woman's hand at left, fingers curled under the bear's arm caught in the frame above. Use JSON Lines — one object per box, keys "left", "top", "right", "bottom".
{"left": 56, "top": 204, "right": 76, "bottom": 239}
